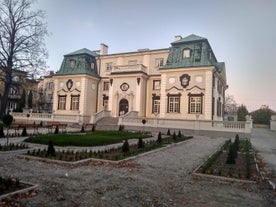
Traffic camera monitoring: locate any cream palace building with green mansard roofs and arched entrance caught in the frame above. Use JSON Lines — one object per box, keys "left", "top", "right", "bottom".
{"left": 44, "top": 34, "right": 228, "bottom": 123}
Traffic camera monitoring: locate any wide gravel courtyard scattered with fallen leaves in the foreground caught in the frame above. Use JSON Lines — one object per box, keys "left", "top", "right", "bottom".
{"left": 0, "top": 136, "right": 275, "bottom": 207}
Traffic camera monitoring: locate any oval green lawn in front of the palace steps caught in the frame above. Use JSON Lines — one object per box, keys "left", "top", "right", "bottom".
{"left": 25, "top": 131, "right": 151, "bottom": 146}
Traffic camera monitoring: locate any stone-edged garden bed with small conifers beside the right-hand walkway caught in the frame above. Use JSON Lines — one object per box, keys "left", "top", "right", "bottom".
{"left": 195, "top": 139, "right": 260, "bottom": 181}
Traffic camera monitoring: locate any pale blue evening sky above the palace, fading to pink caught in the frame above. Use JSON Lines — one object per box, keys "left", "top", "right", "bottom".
{"left": 34, "top": 0, "right": 276, "bottom": 111}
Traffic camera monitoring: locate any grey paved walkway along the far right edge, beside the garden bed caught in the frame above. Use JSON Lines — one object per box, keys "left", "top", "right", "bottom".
{"left": 251, "top": 128, "right": 276, "bottom": 188}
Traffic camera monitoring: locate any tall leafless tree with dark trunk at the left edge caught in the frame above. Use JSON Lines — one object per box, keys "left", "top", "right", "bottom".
{"left": 0, "top": 0, "right": 48, "bottom": 116}
